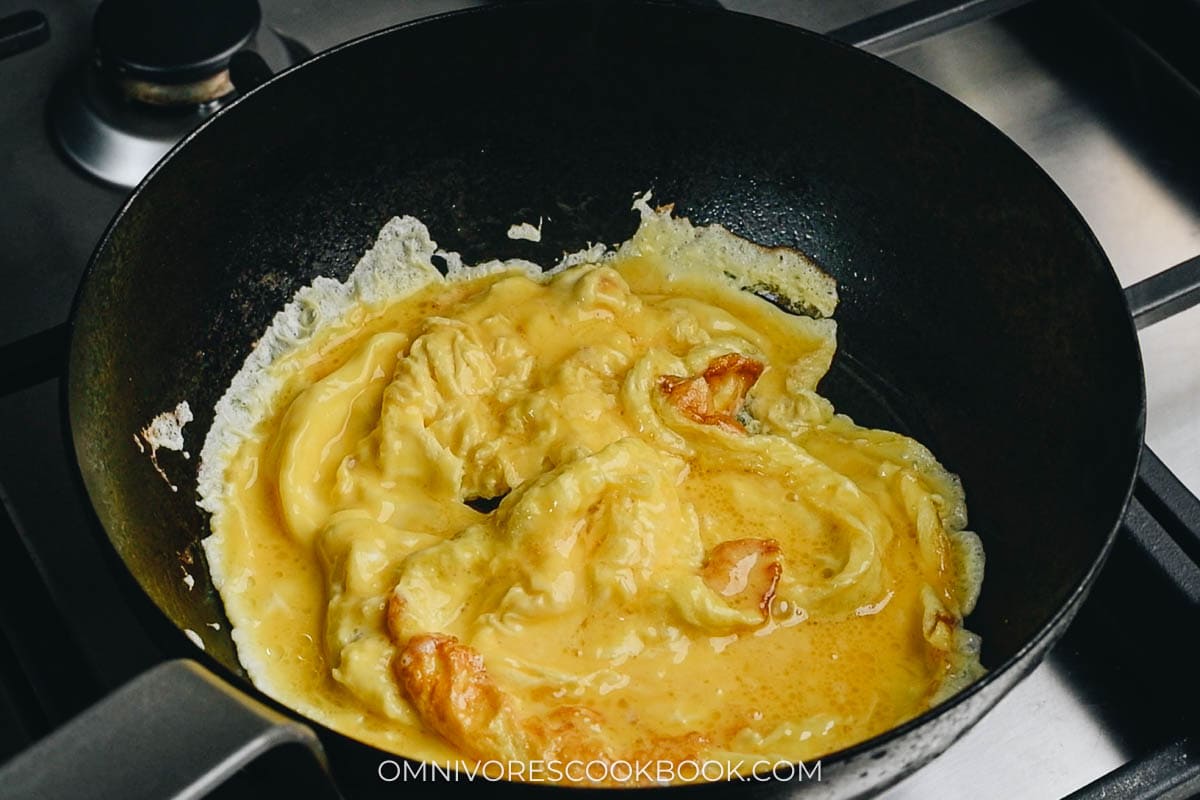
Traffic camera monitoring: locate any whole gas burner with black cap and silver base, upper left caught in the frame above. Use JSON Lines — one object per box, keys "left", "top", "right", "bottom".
{"left": 50, "top": 0, "right": 308, "bottom": 187}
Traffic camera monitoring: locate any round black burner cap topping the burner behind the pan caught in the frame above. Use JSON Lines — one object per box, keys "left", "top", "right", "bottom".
{"left": 92, "top": 0, "right": 263, "bottom": 85}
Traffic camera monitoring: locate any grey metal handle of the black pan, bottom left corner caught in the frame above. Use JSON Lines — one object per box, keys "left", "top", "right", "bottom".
{"left": 0, "top": 658, "right": 341, "bottom": 800}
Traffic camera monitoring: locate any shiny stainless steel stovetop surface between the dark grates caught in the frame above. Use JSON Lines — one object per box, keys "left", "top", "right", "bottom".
{"left": 0, "top": 0, "right": 1200, "bottom": 799}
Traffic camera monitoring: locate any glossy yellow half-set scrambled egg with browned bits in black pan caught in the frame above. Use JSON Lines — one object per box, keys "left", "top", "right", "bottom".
{"left": 200, "top": 201, "right": 983, "bottom": 782}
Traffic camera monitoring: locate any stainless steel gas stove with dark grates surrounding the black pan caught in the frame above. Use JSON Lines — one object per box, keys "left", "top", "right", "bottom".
{"left": 0, "top": 0, "right": 1200, "bottom": 800}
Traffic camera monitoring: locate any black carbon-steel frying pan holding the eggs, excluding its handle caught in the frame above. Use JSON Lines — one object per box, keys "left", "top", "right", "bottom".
{"left": 7, "top": 2, "right": 1144, "bottom": 796}
